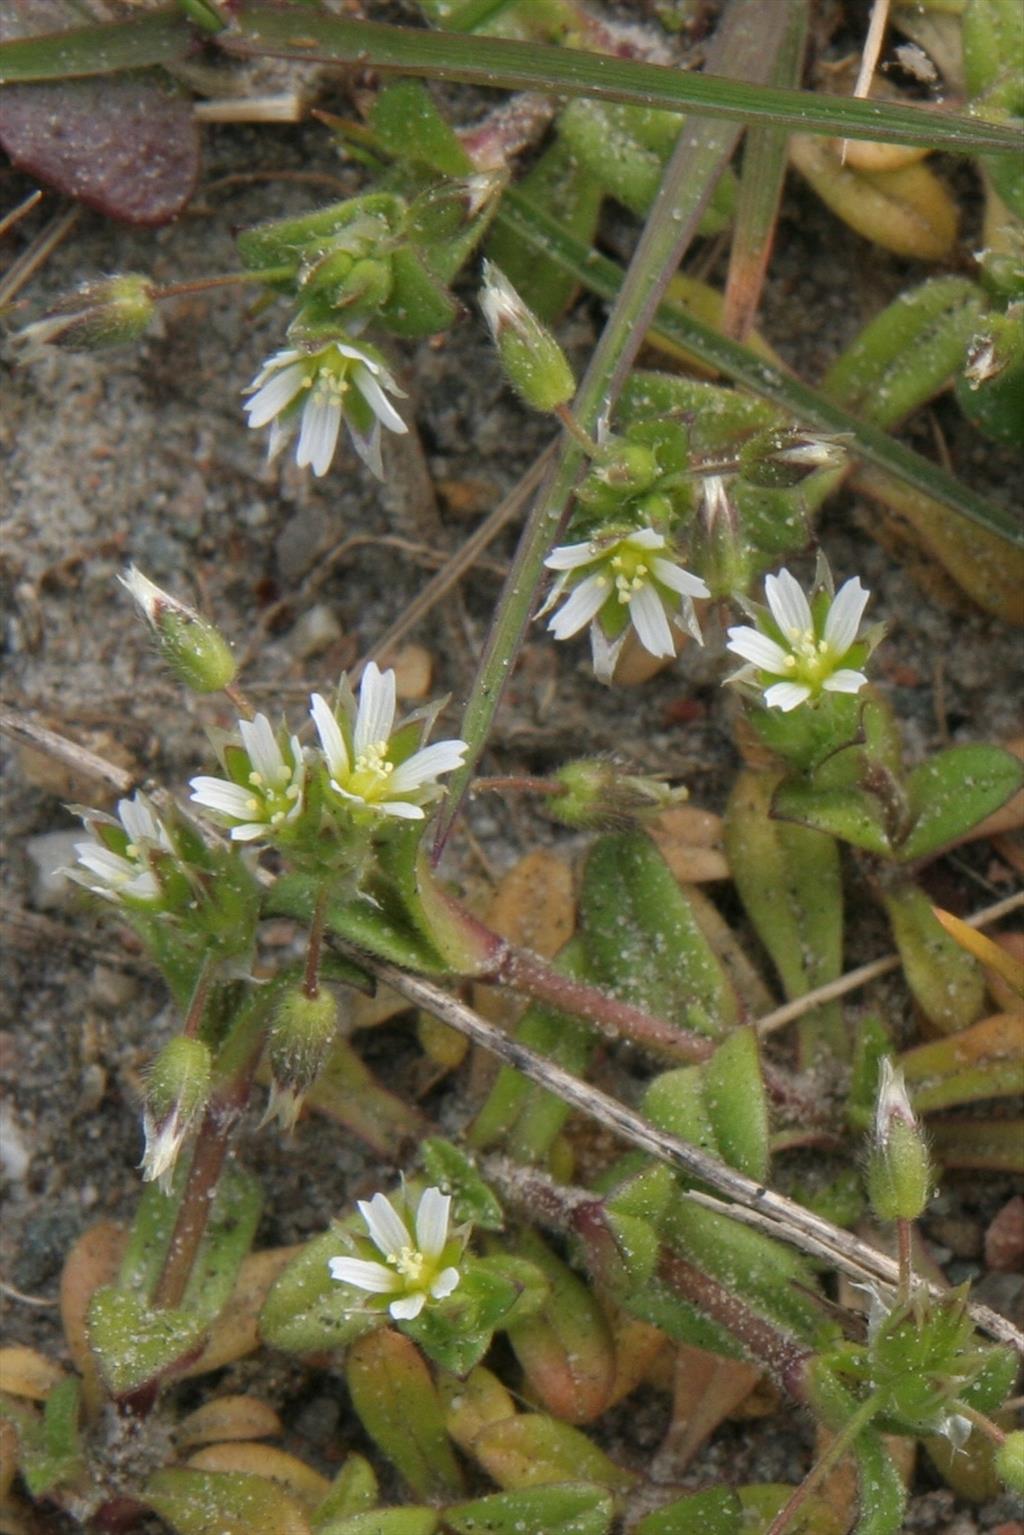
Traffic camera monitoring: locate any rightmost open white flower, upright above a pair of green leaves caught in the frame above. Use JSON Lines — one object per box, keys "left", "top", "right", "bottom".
{"left": 726, "top": 569, "right": 870, "bottom": 714}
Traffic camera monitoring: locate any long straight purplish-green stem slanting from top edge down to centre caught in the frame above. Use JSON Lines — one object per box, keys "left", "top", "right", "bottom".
{"left": 433, "top": 0, "right": 783, "bottom": 861}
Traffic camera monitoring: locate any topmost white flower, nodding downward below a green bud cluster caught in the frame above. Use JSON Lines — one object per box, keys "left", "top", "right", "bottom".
{"left": 246, "top": 341, "right": 408, "bottom": 479}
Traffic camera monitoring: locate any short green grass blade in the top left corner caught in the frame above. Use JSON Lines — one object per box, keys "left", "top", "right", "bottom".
{"left": 0, "top": 6, "right": 192, "bottom": 84}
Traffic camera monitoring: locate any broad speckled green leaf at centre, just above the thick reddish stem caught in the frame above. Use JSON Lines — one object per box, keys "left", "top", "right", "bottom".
{"left": 580, "top": 832, "right": 737, "bottom": 1036}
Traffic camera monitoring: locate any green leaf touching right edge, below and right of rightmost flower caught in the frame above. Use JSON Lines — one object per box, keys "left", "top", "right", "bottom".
{"left": 898, "top": 746, "right": 1024, "bottom": 863}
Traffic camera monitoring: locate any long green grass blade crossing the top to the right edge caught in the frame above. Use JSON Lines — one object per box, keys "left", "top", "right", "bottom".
{"left": 225, "top": 0, "right": 1024, "bottom": 154}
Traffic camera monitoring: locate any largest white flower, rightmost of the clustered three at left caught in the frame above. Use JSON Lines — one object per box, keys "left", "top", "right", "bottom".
{"left": 310, "top": 662, "right": 467, "bottom": 821}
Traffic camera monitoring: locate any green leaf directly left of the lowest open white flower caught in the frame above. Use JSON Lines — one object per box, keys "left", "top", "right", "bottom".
{"left": 259, "top": 1217, "right": 387, "bottom": 1354}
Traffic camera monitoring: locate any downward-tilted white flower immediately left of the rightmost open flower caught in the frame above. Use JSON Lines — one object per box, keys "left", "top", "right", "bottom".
{"left": 540, "top": 528, "right": 711, "bottom": 682}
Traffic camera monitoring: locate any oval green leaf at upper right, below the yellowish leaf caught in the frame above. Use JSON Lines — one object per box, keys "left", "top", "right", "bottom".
{"left": 823, "top": 278, "right": 984, "bottom": 427}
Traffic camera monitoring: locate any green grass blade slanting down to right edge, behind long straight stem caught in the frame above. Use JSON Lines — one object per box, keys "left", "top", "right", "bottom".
{"left": 497, "top": 189, "right": 1024, "bottom": 546}
